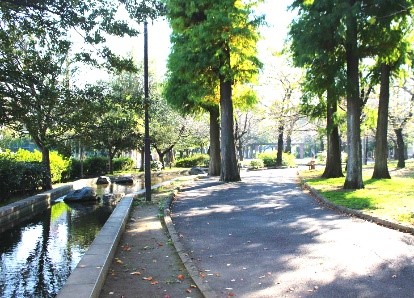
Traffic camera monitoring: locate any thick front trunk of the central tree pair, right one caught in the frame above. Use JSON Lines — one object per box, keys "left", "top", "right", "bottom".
{"left": 220, "top": 76, "right": 241, "bottom": 182}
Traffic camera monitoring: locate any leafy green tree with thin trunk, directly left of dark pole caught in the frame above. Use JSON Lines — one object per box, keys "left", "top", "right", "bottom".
{"left": 79, "top": 70, "right": 144, "bottom": 173}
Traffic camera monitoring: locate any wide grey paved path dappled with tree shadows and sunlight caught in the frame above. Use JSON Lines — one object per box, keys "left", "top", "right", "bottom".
{"left": 172, "top": 170, "right": 414, "bottom": 298}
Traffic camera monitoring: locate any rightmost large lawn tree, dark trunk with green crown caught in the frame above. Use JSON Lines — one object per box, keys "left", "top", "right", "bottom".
{"left": 367, "top": 0, "right": 413, "bottom": 179}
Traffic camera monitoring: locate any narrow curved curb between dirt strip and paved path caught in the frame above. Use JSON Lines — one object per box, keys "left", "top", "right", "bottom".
{"left": 164, "top": 184, "right": 222, "bottom": 298}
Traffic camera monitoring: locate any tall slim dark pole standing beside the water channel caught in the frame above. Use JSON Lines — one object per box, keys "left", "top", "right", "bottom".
{"left": 144, "top": 21, "right": 151, "bottom": 202}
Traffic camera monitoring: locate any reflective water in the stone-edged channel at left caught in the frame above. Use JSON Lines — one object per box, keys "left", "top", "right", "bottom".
{"left": 0, "top": 177, "right": 180, "bottom": 297}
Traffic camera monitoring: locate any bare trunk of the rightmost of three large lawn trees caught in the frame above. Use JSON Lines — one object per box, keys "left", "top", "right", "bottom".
{"left": 372, "top": 63, "right": 391, "bottom": 179}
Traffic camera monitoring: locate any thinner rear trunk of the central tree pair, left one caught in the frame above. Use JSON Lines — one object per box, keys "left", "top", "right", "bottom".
{"left": 208, "top": 106, "right": 221, "bottom": 176}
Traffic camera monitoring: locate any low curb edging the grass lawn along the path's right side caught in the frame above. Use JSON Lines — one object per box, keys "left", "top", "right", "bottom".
{"left": 300, "top": 178, "right": 414, "bottom": 235}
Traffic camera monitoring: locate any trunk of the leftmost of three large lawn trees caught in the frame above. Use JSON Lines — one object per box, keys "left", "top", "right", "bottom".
{"left": 322, "top": 89, "right": 344, "bottom": 178}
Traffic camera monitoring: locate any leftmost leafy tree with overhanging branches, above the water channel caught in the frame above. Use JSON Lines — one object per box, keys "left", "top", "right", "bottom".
{"left": 0, "top": 0, "right": 162, "bottom": 189}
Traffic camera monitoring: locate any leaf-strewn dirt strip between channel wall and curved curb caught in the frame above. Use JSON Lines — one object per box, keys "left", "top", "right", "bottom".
{"left": 100, "top": 203, "right": 203, "bottom": 298}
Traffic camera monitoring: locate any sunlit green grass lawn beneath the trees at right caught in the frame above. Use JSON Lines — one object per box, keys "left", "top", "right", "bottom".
{"left": 300, "top": 160, "right": 414, "bottom": 225}
